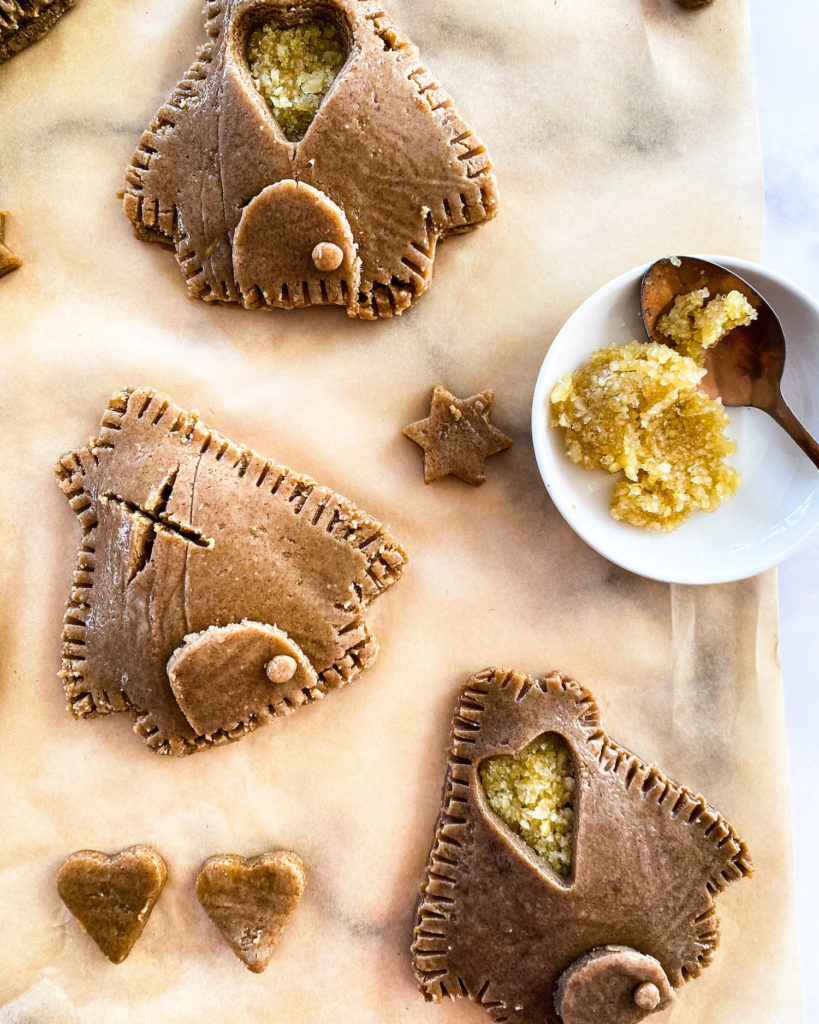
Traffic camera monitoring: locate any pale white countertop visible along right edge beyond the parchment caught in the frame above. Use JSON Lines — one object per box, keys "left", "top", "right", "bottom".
{"left": 750, "top": 0, "right": 819, "bottom": 1011}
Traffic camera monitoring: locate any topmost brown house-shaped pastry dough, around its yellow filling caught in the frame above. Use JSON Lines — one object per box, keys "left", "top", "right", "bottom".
{"left": 123, "top": 0, "right": 498, "bottom": 319}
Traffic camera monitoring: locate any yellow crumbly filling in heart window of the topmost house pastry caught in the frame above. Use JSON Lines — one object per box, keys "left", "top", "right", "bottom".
{"left": 247, "top": 17, "right": 347, "bottom": 142}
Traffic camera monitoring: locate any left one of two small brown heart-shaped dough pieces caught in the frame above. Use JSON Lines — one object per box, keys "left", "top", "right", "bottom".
{"left": 57, "top": 846, "right": 168, "bottom": 964}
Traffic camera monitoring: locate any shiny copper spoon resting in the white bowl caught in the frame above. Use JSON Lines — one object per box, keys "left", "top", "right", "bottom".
{"left": 640, "top": 256, "right": 819, "bottom": 469}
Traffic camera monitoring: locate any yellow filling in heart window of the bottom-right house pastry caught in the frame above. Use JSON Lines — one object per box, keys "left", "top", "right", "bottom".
{"left": 479, "top": 732, "right": 575, "bottom": 877}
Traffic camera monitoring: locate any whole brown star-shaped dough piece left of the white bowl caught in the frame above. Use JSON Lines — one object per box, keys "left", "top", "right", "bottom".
{"left": 403, "top": 384, "right": 512, "bottom": 487}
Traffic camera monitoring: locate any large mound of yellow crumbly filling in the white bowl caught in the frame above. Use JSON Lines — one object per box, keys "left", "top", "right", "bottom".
{"left": 552, "top": 341, "right": 741, "bottom": 531}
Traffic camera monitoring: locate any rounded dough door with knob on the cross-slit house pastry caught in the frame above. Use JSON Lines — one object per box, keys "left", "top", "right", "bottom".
{"left": 168, "top": 622, "right": 318, "bottom": 736}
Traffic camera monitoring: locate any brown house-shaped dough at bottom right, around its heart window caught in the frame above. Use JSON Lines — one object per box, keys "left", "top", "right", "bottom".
{"left": 413, "top": 669, "right": 751, "bottom": 1024}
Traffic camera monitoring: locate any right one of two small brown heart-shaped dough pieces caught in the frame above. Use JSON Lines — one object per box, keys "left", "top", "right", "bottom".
{"left": 197, "top": 850, "right": 305, "bottom": 974}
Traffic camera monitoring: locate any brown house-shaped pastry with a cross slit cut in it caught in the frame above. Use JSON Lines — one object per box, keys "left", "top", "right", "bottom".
{"left": 56, "top": 388, "right": 406, "bottom": 754}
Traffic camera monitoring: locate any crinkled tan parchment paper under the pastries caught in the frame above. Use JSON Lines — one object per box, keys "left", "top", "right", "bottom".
{"left": 0, "top": 0, "right": 800, "bottom": 1024}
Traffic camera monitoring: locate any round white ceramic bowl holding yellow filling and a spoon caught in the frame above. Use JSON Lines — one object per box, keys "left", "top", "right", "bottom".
{"left": 531, "top": 256, "right": 819, "bottom": 584}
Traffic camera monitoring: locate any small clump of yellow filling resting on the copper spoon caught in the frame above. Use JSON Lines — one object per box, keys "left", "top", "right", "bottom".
{"left": 657, "top": 288, "right": 757, "bottom": 366}
